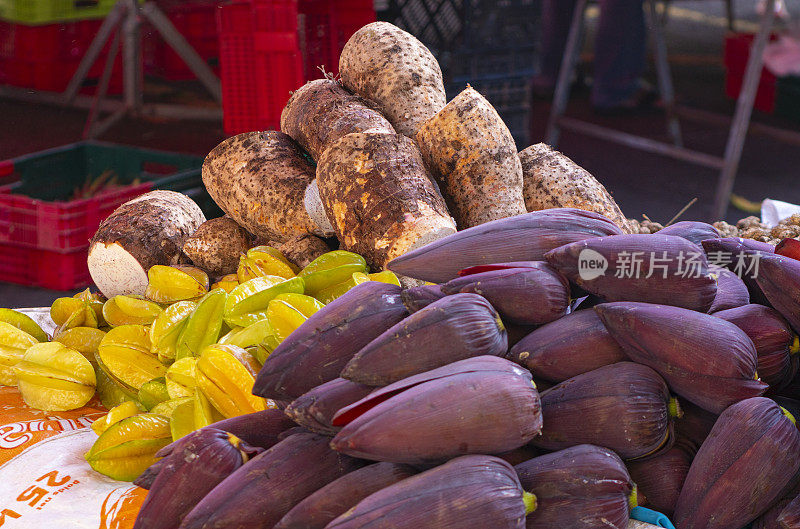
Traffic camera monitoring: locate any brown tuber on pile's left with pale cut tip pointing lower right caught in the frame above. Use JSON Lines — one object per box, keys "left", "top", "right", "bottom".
{"left": 203, "top": 131, "right": 333, "bottom": 241}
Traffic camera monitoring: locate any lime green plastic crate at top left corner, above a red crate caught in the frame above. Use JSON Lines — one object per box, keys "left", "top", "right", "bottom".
{"left": 0, "top": 0, "right": 142, "bottom": 24}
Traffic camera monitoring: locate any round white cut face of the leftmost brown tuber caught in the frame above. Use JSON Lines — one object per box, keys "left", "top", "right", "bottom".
{"left": 86, "top": 242, "right": 148, "bottom": 299}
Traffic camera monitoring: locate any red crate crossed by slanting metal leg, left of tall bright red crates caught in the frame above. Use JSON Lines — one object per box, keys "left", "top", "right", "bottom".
{"left": 145, "top": 0, "right": 219, "bottom": 81}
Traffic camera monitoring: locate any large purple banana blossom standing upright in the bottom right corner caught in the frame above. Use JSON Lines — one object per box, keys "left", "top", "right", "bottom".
{"left": 674, "top": 397, "right": 800, "bottom": 529}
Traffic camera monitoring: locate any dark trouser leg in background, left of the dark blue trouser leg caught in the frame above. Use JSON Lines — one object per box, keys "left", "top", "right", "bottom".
{"left": 534, "top": 0, "right": 576, "bottom": 89}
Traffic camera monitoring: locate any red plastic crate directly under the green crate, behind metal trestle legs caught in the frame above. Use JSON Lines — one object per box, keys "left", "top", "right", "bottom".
{"left": 0, "top": 20, "right": 122, "bottom": 94}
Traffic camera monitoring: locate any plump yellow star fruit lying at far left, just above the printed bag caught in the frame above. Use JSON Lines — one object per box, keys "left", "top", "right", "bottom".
{"left": 14, "top": 342, "right": 97, "bottom": 411}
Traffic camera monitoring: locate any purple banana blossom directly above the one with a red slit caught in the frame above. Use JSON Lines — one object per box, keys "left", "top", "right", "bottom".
{"left": 342, "top": 294, "right": 508, "bottom": 386}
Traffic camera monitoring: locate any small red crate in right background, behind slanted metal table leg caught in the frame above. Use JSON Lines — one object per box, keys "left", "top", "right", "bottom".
{"left": 723, "top": 33, "right": 778, "bottom": 114}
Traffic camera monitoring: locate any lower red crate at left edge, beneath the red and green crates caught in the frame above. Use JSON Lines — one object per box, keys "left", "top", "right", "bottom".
{"left": 0, "top": 243, "right": 92, "bottom": 290}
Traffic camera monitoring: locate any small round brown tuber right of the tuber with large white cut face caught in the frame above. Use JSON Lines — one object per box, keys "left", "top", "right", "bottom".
{"left": 183, "top": 217, "right": 250, "bottom": 276}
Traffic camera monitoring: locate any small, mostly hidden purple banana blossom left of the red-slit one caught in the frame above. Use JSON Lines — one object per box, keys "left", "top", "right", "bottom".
{"left": 285, "top": 378, "right": 375, "bottom": 435}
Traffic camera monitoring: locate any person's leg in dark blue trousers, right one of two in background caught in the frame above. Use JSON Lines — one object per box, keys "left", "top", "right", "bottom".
{"left": 592, "top": 0, "right": 647, "bottom": 108}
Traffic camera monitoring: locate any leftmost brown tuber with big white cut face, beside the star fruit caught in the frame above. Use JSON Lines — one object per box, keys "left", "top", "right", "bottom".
{"left": 87, "top": 191, "right": 206, "bottom": 298}
